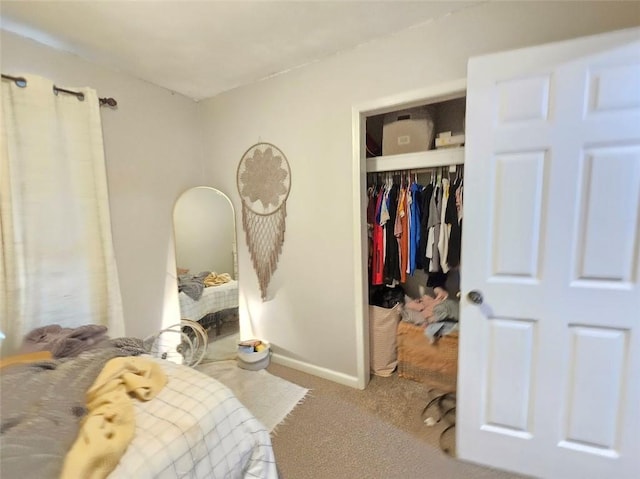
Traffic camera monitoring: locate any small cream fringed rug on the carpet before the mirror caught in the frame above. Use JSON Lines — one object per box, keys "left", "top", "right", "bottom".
{"left": 196, "top": 361, "right": 309, "bottom": 433}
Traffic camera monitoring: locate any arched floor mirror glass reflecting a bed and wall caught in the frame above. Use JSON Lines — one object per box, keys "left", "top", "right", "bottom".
{"left": 173, "top": 186, "right": 239, "bottom": 360}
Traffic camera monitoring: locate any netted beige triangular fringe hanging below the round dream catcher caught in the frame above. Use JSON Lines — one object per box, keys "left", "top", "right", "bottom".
{"left": 242, "top": 204, "right": 287, "bottom": 301}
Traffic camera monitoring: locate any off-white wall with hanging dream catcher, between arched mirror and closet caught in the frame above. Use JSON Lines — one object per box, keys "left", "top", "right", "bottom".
{"left": 202, "top": 2, "right": 640, "bottom": 384}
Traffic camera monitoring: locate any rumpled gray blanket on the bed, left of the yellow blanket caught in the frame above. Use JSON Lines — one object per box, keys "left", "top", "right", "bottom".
{"left": 0, "top": 339, "right": 143, "bottom": 479}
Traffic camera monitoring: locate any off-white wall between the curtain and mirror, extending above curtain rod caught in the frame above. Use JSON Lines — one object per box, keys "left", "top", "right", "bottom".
{"left": 1, "top": 31, "right": 202, "bottom": 337}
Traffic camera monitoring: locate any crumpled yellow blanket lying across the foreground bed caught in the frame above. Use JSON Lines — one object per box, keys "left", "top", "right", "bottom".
{"left": 61, "top": 357, "right": 167, "bottom": 479}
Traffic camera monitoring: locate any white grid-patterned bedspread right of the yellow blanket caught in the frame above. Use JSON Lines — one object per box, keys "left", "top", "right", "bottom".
{"left": 108, "top": 359, "right": 278, "bottom": 479}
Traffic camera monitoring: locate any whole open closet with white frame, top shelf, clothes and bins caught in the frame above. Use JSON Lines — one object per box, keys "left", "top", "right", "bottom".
{"left": 354, "top": 84, "right": 466, "bottom": 456}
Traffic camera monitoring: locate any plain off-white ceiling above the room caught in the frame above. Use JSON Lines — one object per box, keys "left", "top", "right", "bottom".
{"left": 0, "top": 0, "right": 482, "bottom": 100}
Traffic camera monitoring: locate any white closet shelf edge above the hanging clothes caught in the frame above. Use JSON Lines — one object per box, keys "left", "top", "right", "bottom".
{"left": 367, "top": 147, "right": 464, "bottom": 173}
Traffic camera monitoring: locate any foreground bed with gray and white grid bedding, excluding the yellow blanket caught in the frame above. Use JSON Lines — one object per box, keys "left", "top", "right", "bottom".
{"left": 0, "top": 338, "right": 278, "bottom": 479}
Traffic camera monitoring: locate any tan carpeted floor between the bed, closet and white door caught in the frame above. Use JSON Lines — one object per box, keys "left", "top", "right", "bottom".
{"left": 267, "top": 362, "right": 523, "bottom": 479}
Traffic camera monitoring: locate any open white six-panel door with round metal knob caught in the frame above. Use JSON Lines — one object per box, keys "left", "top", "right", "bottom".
{"left": 456, "top": 29, "right": 640, "bottom": 479}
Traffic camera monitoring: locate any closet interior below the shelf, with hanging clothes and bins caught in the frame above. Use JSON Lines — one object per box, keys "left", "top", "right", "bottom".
{"left": 367, "top": 164, "right": 464, "bottom": 386}
